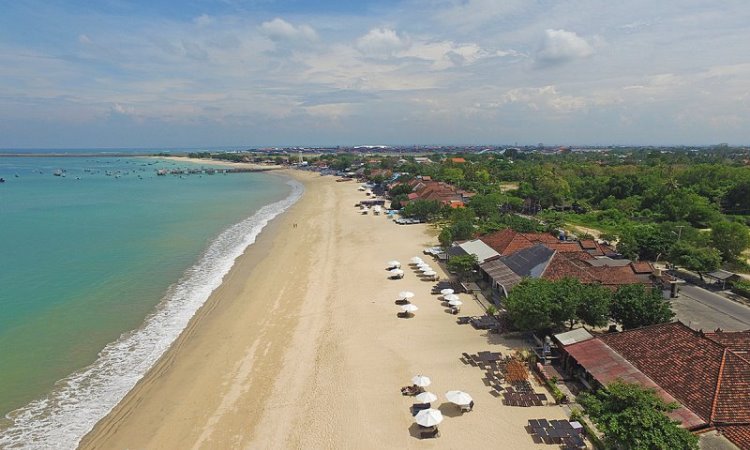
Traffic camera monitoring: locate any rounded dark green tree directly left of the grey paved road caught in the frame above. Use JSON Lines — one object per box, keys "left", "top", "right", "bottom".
{"left": 611, "top": 284, "right": 674, "bottom": 330}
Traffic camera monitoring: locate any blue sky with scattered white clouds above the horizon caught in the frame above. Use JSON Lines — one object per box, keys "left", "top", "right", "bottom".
{"left": 0, "top": 0, "right": 750, "bottom": 149}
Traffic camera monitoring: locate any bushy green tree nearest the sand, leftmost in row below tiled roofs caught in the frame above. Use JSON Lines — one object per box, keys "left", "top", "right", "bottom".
{"left": 505, "top": 278, "right": 555, "bottom": 331}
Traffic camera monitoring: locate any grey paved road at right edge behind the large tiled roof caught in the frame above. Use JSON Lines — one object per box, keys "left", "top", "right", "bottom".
{"left": 672, "top": 284, "right": 750, "bottom": 331}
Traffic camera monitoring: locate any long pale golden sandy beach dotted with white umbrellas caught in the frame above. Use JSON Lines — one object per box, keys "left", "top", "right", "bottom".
{"left": 81, "top": 172, "right": 565, "bottom": 449}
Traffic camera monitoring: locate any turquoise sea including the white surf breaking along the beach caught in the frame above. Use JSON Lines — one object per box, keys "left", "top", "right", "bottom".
{"left": 0, "top": 157, "right": 302, "bottom": 448}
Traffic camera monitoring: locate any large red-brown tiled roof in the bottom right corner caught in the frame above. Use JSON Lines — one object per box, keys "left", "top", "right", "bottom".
{"left": 565, "top": 322, "right": 750, "bottom": 449}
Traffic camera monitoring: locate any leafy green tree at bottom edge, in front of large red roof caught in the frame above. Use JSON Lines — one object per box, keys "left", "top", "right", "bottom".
{"left": 578, "top": 381, "right": 698, "bottom": 450}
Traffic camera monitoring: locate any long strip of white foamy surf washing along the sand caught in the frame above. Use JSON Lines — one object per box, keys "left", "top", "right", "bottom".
{"left": 0, "top": 181, "right": 303, "bottom": 449}
